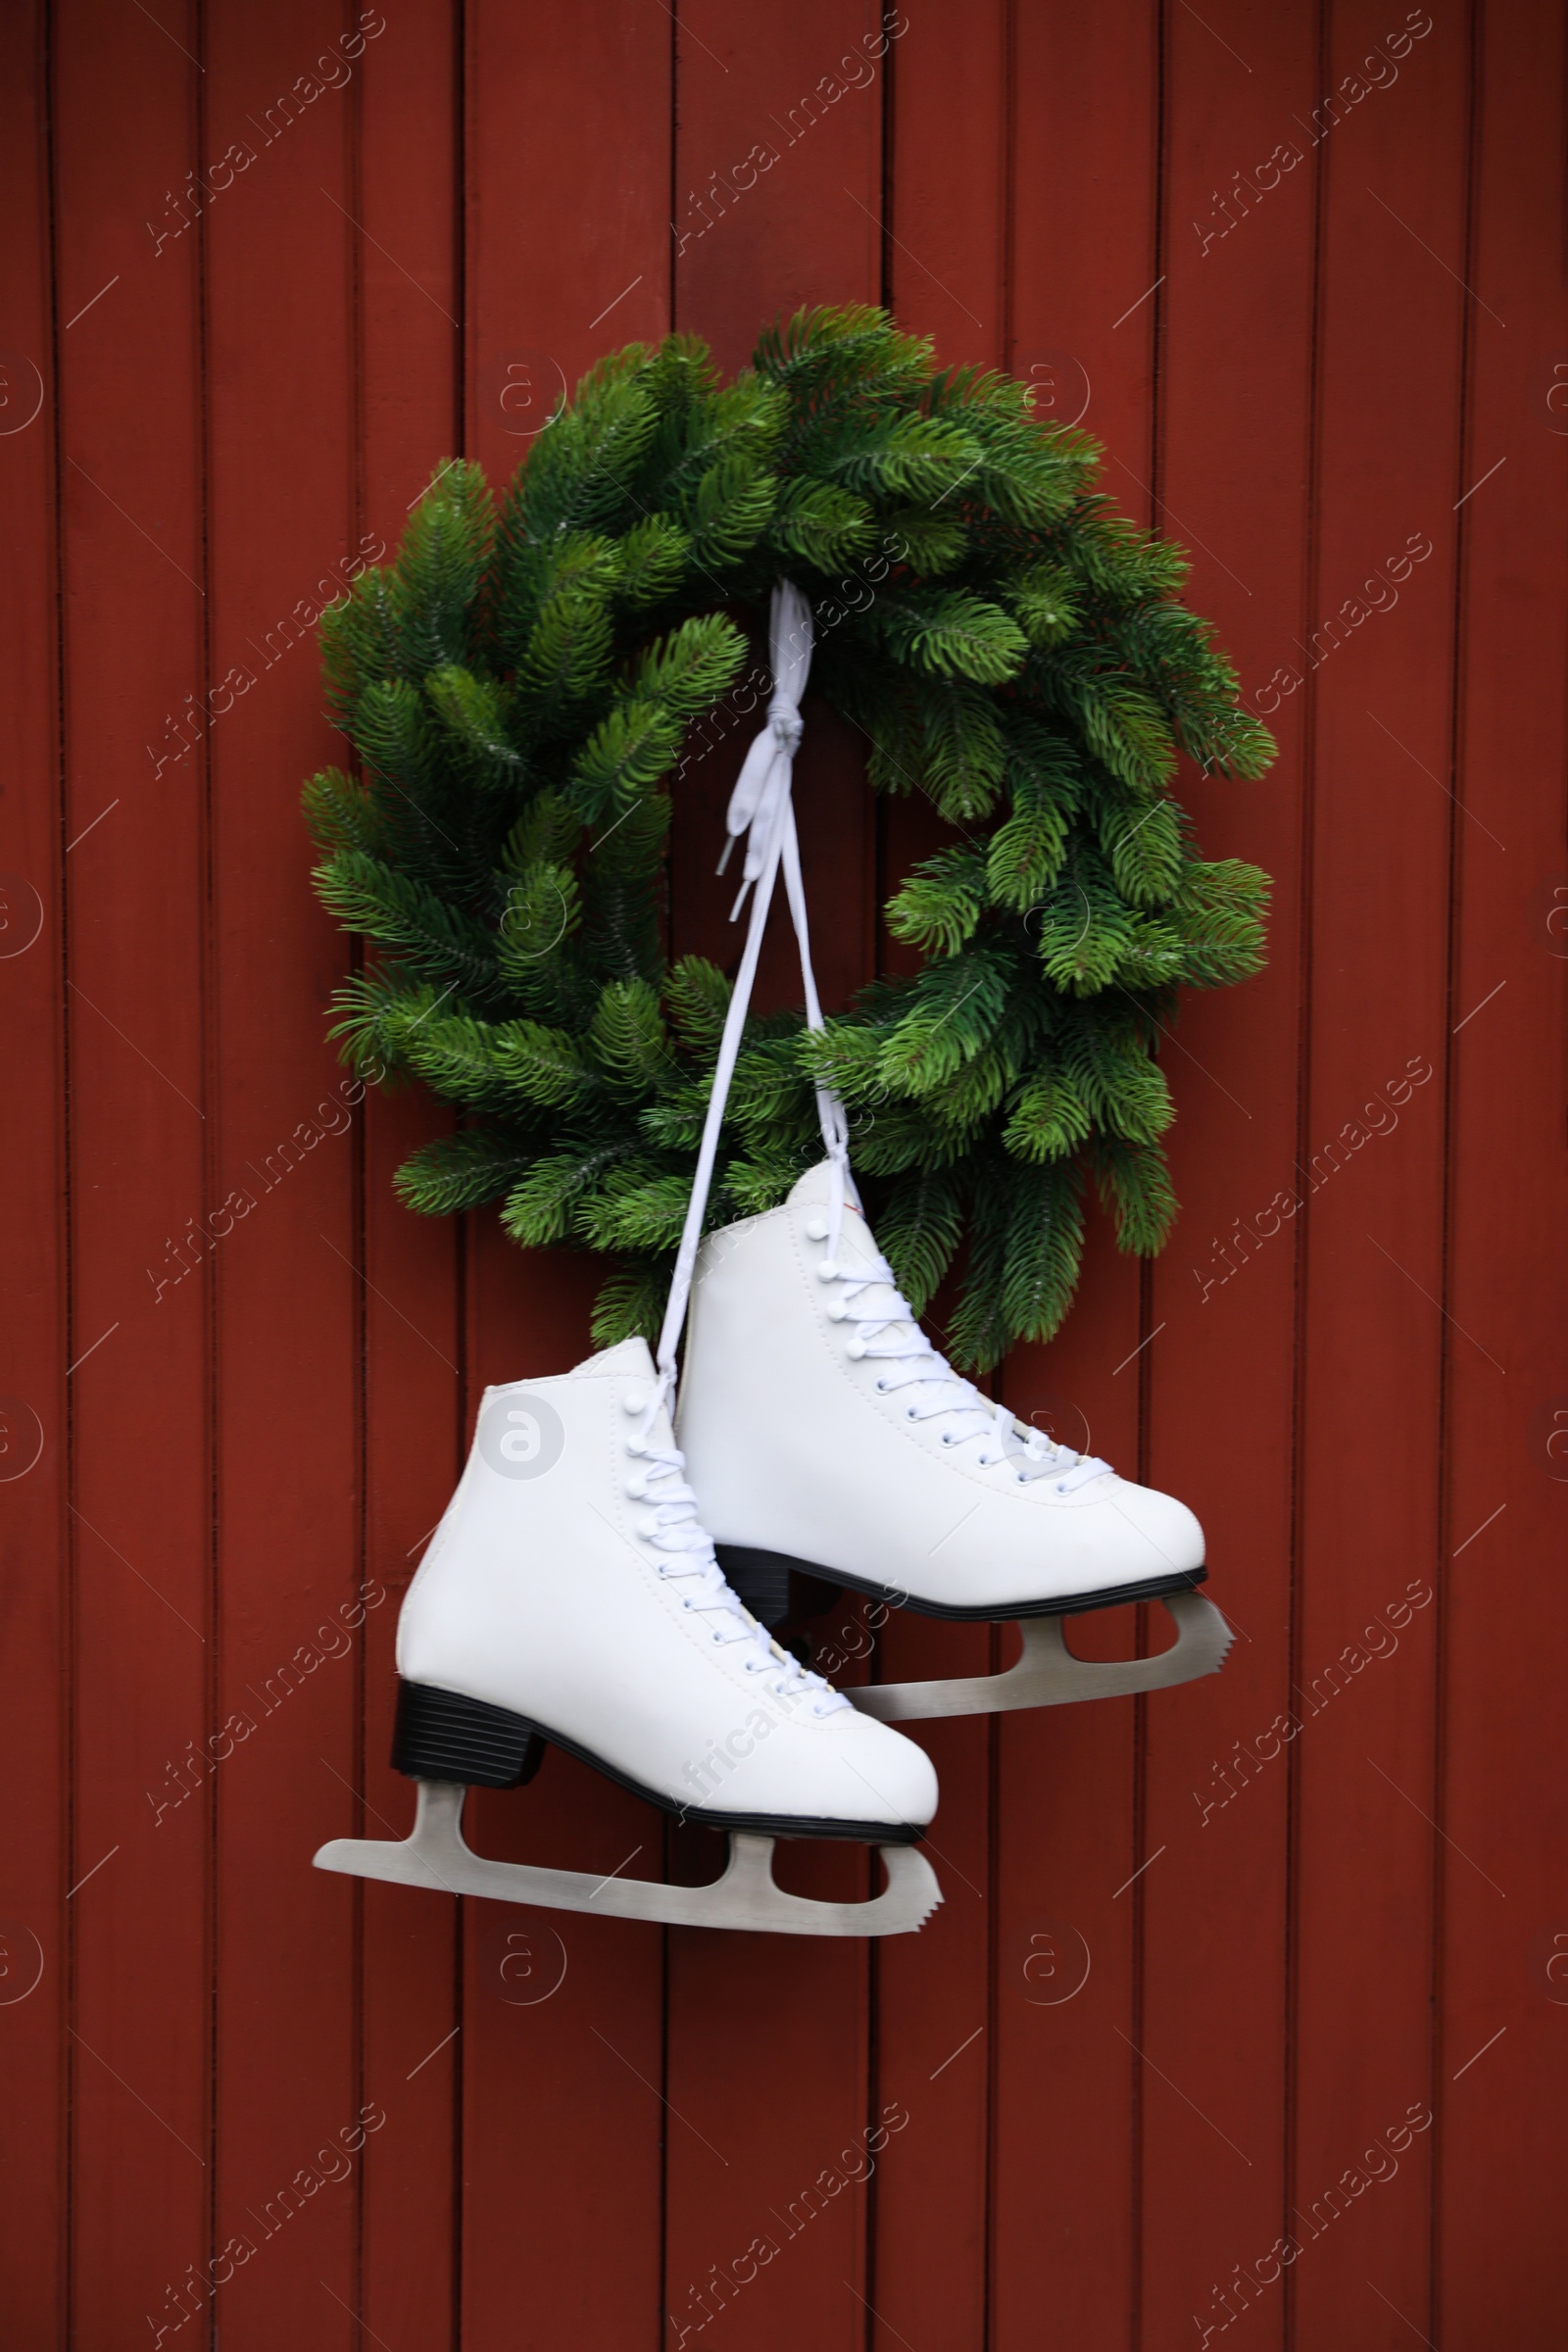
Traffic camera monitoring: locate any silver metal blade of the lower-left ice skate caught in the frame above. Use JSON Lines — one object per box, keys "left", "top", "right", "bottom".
{"left": 315, "top": 1781, "right": 943, "bottom": 1936}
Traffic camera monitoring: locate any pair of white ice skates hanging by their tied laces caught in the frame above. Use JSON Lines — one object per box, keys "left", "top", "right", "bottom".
{"left": 318, "top": 588, "right": 1230, "bottom": 1936}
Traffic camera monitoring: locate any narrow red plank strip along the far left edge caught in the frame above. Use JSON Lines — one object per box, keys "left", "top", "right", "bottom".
{"left": 0, "top": 10, "right": 73, "bottom": 2345}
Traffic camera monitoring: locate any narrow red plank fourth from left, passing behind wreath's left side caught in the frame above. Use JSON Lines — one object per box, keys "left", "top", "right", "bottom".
{"left": 353, "top": 10, "right": 466, "bottom": 2345}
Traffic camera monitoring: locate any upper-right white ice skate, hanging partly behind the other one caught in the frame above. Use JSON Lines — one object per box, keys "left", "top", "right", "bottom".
{"left": 679, "top": 1154, "right": 1230, "bottom": 1719}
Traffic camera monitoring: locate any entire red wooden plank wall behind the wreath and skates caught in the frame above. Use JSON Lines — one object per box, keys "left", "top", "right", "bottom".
{"left": 0, "top": 0, "right": 1568, "bottom": 2352}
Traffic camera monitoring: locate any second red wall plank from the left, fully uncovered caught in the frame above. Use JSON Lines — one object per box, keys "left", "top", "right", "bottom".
{"left": 54, "top": 12, "right": 216, "bottom": 2335}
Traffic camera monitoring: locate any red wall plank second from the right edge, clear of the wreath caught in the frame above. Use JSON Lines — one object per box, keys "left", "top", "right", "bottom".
{"left": 1298, "top": 7, "right": 1466, "bottom": 2347}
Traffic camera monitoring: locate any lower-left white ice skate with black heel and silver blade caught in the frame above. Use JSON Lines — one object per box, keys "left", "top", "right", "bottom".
{"left": 315, "top": 1339, "right": 941, "bottom": 1936}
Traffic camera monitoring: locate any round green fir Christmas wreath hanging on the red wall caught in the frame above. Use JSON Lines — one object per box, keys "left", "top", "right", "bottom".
{"left": 306, "top": 308, "right": 1272, "bottom": 1366}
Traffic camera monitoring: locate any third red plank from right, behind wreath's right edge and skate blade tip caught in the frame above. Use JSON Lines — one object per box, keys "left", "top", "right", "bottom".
{"left": 1140, "top": 7, "right": 1319, "bottom": 2347}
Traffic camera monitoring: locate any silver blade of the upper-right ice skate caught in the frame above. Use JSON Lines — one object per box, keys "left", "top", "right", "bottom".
{"left": 844, "top": 1592, "right": 1232, "bottom": 1724}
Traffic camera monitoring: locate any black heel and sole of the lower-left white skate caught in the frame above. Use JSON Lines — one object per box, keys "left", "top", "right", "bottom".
{"left": 393, "top": 1682, "right": 926, "bottom": 1846}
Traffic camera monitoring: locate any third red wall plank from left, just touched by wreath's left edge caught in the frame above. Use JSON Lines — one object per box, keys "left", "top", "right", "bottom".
{"left": 202, "top": 14, "right": 364, "bottom": 2352}
